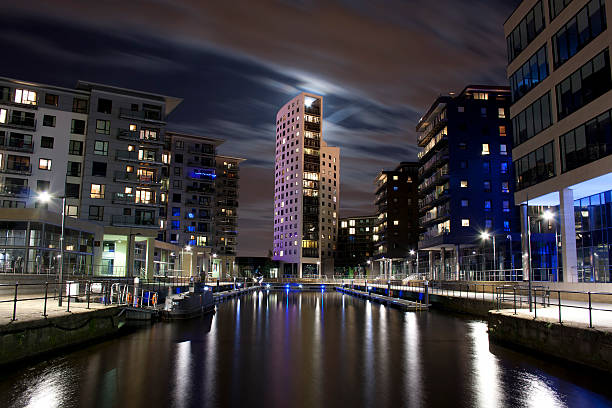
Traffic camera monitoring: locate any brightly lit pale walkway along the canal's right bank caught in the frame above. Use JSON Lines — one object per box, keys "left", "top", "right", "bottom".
{"left": 368, "top": 284, "right": 612, "bottom": 332}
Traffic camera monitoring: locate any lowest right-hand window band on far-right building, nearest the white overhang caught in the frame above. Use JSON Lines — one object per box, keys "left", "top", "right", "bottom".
{"left": 559, "top": 111, "right": 612, "bottom": 172}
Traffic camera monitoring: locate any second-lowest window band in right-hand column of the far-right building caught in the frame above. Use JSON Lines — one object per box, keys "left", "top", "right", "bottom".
{"left": 556, "top": 49, "right": 612, "bottom": 120}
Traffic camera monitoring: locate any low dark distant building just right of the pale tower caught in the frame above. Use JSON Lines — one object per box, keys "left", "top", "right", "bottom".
{"left": 335, "top": 215, "right": 378, "bottom": 275}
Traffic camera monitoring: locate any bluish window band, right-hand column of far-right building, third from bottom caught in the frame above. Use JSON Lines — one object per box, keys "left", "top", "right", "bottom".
{"left": 552, "top": 0, "right": 606, "bottom": 68}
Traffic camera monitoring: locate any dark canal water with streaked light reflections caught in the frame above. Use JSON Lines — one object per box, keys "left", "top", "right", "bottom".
{"left": 0, "top": 291, "right": 612, "bottom": 408}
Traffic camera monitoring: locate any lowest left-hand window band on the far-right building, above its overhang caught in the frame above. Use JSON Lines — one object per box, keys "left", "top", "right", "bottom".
{"left": 514, "top": 142, "right": 555, "bottom": 190}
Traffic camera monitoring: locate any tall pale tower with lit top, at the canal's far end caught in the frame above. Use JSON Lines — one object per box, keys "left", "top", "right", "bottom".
{"left": 273, "top": 92, "right": 340, "bottom": 277}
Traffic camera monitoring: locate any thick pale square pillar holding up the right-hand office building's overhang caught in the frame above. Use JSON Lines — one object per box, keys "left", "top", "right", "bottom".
{"left": 559, "top": 188, "right": 578, "bottom": 282}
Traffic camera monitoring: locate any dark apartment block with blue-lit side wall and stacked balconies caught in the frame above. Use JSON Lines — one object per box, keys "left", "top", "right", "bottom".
{"left": 416, "top": 86, "right": 520, "bottom": 279}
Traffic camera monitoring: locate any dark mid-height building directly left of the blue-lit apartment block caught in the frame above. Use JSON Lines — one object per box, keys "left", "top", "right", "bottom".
{"left": 373, "top": 162, "right": 420, "bottom": 276}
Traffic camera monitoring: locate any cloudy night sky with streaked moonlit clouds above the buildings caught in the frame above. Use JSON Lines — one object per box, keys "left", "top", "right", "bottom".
{"left": 0, "top": 0, "right": 520, "bottom": 256}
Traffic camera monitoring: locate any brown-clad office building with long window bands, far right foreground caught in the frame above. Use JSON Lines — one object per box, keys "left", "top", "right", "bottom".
{"left": 504, "top": 0, "right": 612, "bottom": 282}
